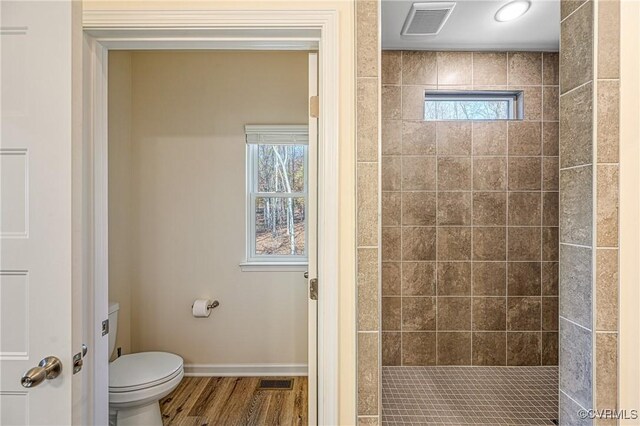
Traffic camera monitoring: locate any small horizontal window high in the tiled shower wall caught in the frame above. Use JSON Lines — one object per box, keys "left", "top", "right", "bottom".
{"left": 424, "top": 91, "right": 524, "bottom": 121}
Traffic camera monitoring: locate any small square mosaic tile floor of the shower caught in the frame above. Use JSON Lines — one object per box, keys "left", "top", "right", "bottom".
{"left": 382, "top": 366, "right": 558, "bottom": 426}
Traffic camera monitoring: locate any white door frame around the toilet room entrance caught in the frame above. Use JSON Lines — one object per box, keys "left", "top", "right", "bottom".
{"left": 83, "top": 10, "right": 339, "bottom": 425}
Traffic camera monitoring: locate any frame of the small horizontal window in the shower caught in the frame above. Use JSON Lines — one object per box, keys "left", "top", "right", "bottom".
{"left": 422, "top": 90, "right": 524, "bottom": 121}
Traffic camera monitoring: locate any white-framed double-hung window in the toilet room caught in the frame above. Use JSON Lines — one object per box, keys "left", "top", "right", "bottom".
{"left": 245, "top": 125, "right": 309, "bottom": 265}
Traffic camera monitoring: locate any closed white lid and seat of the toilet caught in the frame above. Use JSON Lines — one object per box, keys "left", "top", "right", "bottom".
{"left": 109, "top": 352, "right": 183, "bottom": 391}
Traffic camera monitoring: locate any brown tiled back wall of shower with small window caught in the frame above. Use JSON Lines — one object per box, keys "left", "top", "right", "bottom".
{"left": 382, "top": 51, "right": 558, "bottom": 365}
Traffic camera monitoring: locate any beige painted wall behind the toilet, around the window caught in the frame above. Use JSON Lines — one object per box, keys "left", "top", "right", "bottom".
{"left": 109, "top": 52, "right": 308, "bottom": 364}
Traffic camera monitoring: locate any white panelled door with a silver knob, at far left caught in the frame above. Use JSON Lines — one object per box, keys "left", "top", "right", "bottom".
{"left": 0, "top": 0, "right": 74, "bottom": 426}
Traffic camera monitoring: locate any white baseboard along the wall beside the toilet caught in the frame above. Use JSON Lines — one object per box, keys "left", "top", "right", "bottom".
{"left": 184, "top": 364, "right": 308, "bottom": 377}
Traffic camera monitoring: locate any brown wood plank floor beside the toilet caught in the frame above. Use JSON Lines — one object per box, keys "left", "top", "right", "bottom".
{"left": 160, "top": 377, "right": 308, "bottom": 426}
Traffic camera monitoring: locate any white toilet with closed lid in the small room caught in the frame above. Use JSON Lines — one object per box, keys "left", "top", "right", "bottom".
{"left": 109, "top": 302, "right": 184, "bottom": 426}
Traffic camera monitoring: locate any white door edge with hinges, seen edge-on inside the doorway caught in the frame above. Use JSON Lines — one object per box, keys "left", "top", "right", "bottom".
{"left": 307, "top": 53, "right": 318, "bottom": 426}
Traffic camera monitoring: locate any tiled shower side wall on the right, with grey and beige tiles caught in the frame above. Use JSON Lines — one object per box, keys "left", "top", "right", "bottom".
{"left": 559, "top": 0, "right": 624, "bottom": 425}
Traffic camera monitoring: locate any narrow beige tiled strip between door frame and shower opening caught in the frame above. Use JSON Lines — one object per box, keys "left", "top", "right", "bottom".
{"left": 355, "top": 0, "right": 381, "bottom": 425}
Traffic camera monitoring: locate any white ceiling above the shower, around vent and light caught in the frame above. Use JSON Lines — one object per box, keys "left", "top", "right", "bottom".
{"left": 382, "top": 0, "right": 560, "bottom": 51}
